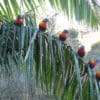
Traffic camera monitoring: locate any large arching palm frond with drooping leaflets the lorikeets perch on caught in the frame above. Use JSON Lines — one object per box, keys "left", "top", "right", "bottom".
{"left": 0, "top": 19, "right": 100, "bottom": 100}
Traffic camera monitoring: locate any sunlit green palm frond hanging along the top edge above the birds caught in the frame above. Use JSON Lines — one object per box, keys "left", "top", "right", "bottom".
{"left": 0, "top": 0, "right": 100, "bottom": 28}
